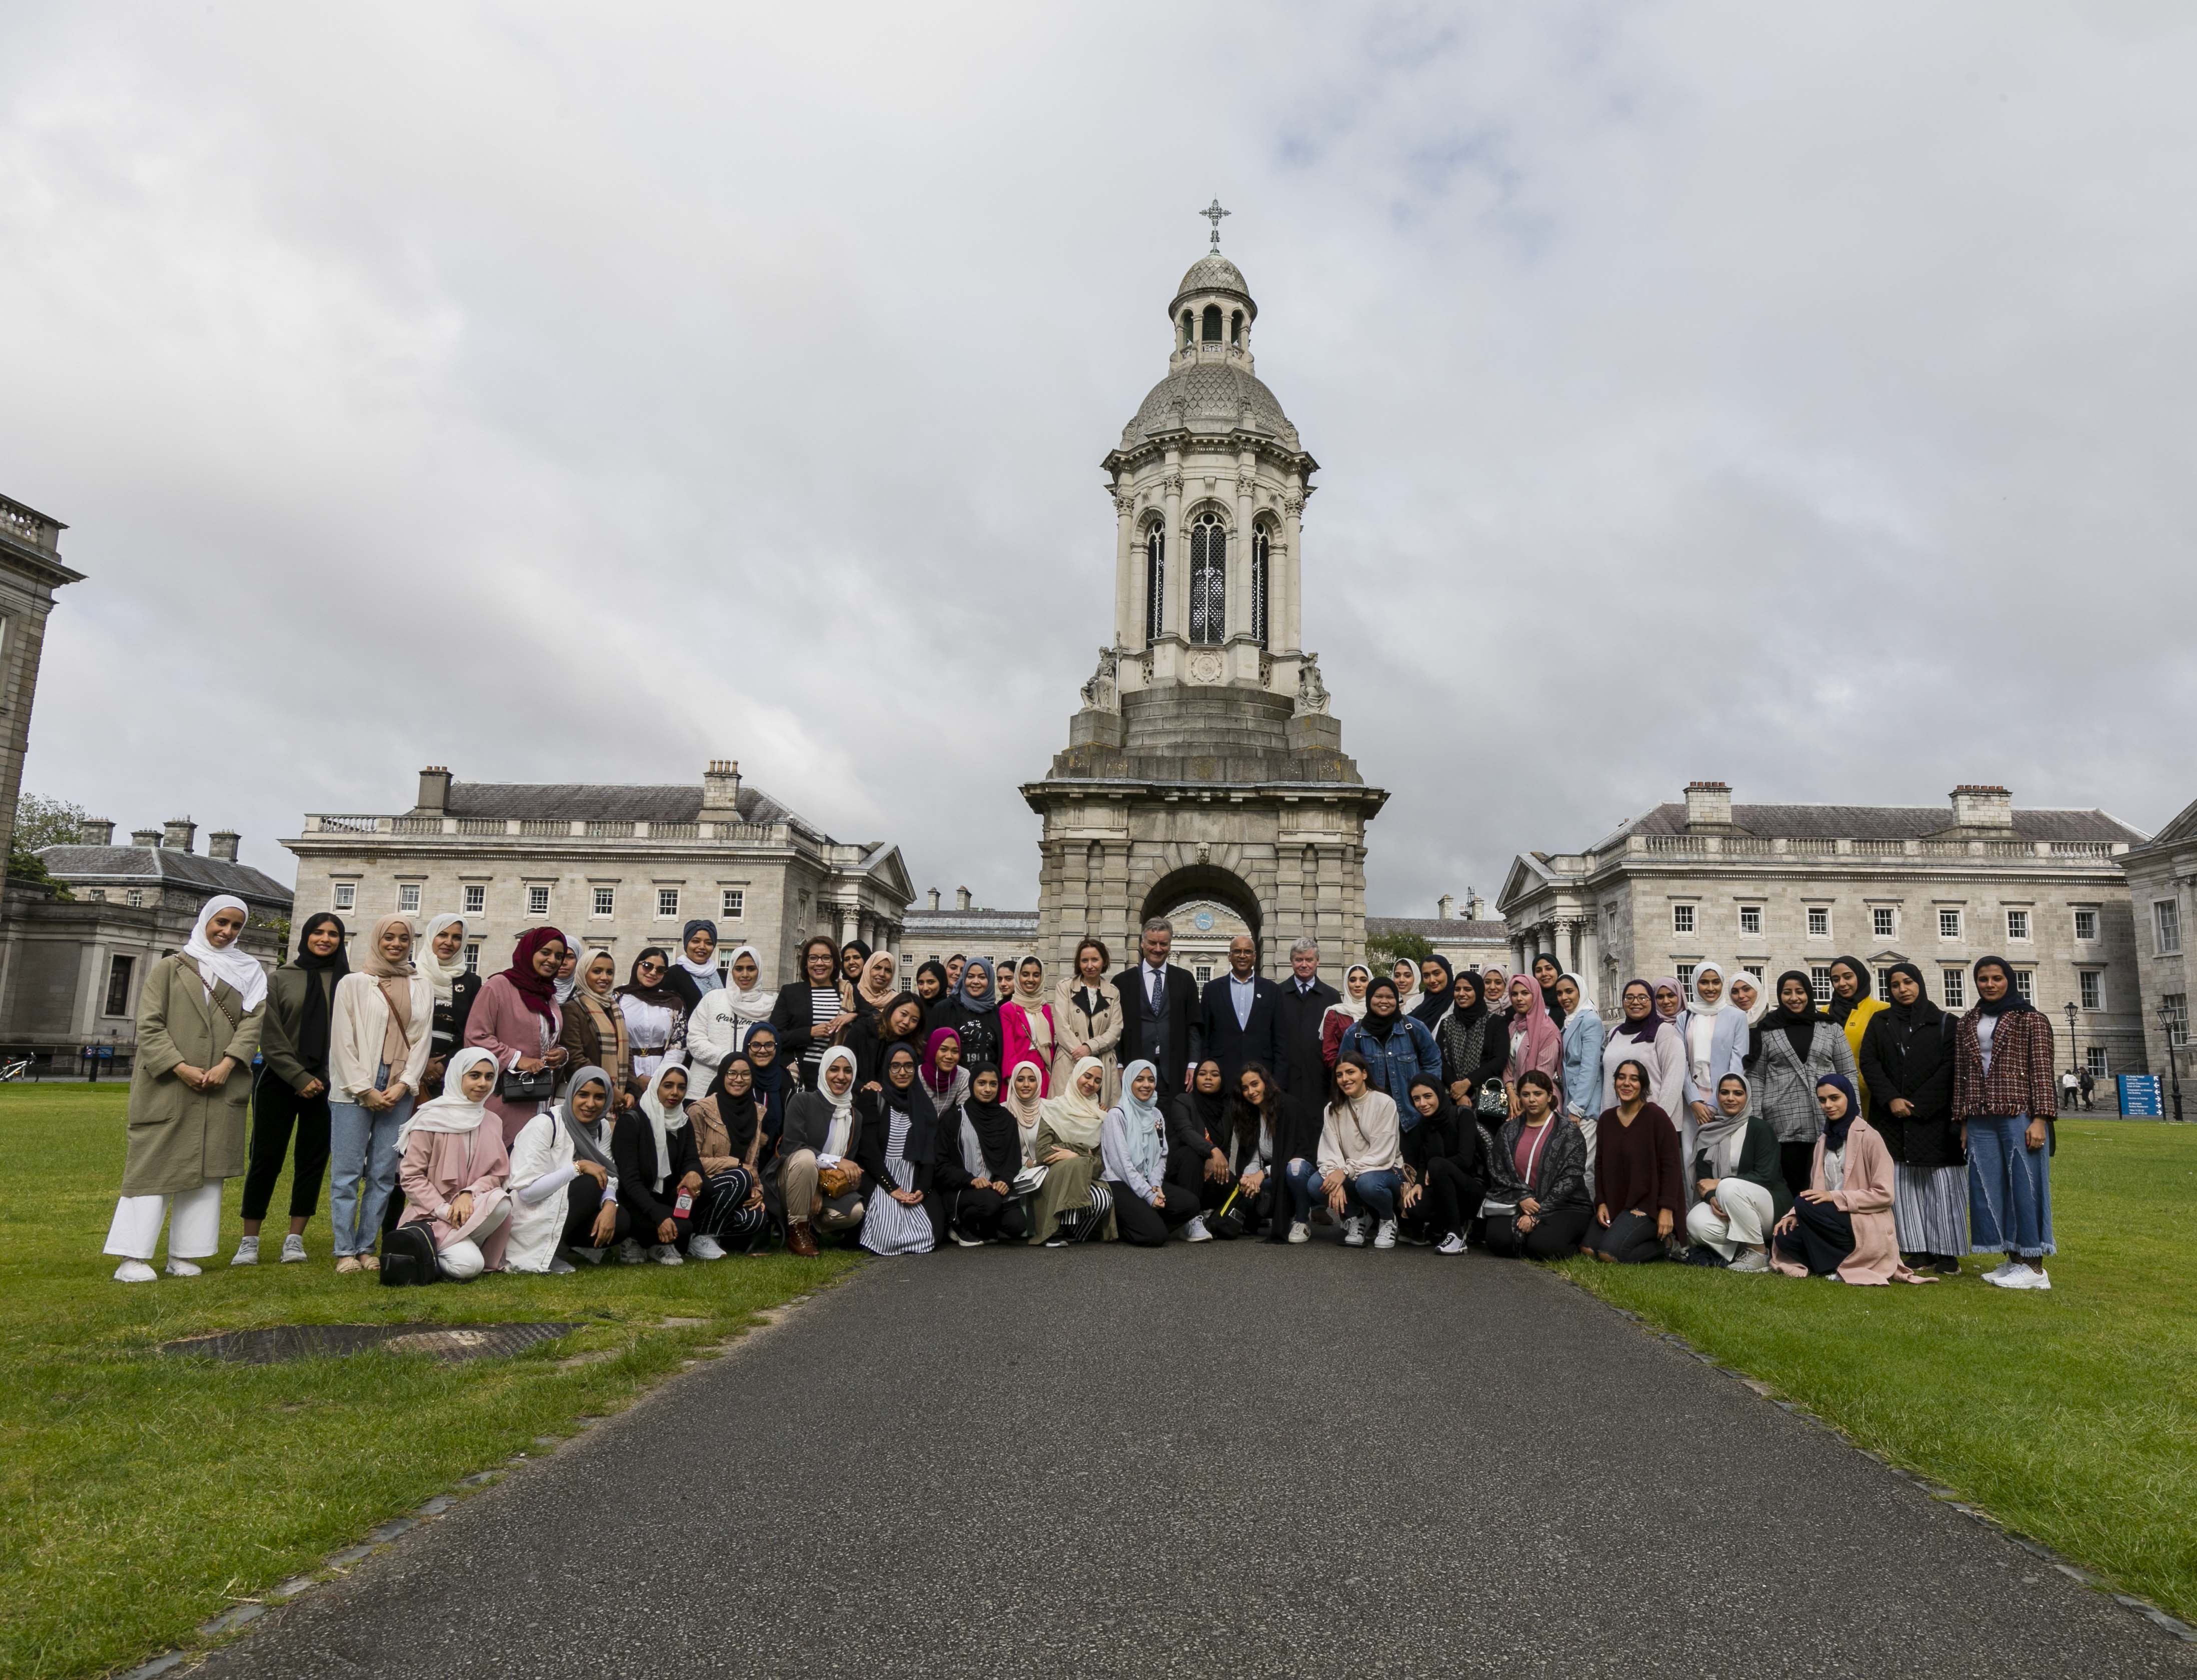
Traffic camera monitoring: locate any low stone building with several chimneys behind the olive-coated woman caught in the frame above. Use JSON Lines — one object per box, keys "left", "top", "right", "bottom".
{"left": 0, "top": 817, "right": 290, "bottom": 1063}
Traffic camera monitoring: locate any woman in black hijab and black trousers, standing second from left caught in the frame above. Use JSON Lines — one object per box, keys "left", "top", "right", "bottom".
{"left": 231, "top": 909, "right": 352, "bottom": 1265}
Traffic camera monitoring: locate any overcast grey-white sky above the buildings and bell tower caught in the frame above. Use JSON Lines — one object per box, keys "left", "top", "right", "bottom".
{"left": 0, "top": 0, "right": 2197, "bottom": 914}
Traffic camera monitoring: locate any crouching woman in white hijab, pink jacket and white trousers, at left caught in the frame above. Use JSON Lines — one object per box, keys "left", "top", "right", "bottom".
{"left": 398, "top": 1050, "right": 512, "bottom": 1282}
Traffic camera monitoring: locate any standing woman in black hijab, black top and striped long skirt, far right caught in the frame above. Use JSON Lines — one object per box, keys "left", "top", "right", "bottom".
{"left": 1856, "top": 962, "right": 1968, "bottom": 1276}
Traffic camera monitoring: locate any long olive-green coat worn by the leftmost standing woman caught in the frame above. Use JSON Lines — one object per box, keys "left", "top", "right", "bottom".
{"left": 123, "top": 956, "right": 266, "bottom": 1197}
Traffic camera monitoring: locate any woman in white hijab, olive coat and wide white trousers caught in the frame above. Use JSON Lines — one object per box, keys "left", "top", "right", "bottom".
{"left": 108, "top": 894, "right": 268, "bottom": 1282}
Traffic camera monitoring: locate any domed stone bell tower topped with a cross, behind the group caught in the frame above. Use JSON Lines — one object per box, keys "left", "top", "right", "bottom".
{"left": 1022, "top": 200, "right": 1388, "bottom": 978}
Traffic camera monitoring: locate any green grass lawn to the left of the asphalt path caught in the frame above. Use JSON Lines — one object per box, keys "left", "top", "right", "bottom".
{"left": 0, "top": 1085, "right": 852, "bottom": 1676}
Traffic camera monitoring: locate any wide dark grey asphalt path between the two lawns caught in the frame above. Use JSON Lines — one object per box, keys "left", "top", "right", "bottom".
{"left": 205, "top": 1241, "right": 2197, "bottom": 1680}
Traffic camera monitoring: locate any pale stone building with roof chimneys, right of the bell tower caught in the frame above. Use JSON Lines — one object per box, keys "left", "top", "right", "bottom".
{"left": 1496, "top": 782, "right": 2146, "bottom": 1076}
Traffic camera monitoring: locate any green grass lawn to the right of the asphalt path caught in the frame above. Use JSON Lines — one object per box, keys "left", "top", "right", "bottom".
{"left": 1564, "top": 1118, "right": 2197, "bottom": 1620}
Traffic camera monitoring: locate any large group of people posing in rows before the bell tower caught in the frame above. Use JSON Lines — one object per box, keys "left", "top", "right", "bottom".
{"left": 108, "top": 896, "right": 2056, "bottom": 1289}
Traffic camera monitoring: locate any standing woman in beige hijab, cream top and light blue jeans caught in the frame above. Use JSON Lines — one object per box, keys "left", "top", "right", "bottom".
{"left": 328, "top": 916, "right": 435, "bottom": 1272}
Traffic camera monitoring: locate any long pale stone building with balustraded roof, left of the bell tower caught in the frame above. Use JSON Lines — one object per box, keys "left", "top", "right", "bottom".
{"left": 284, "top": 760, "right": 914, "bottom": 986}
